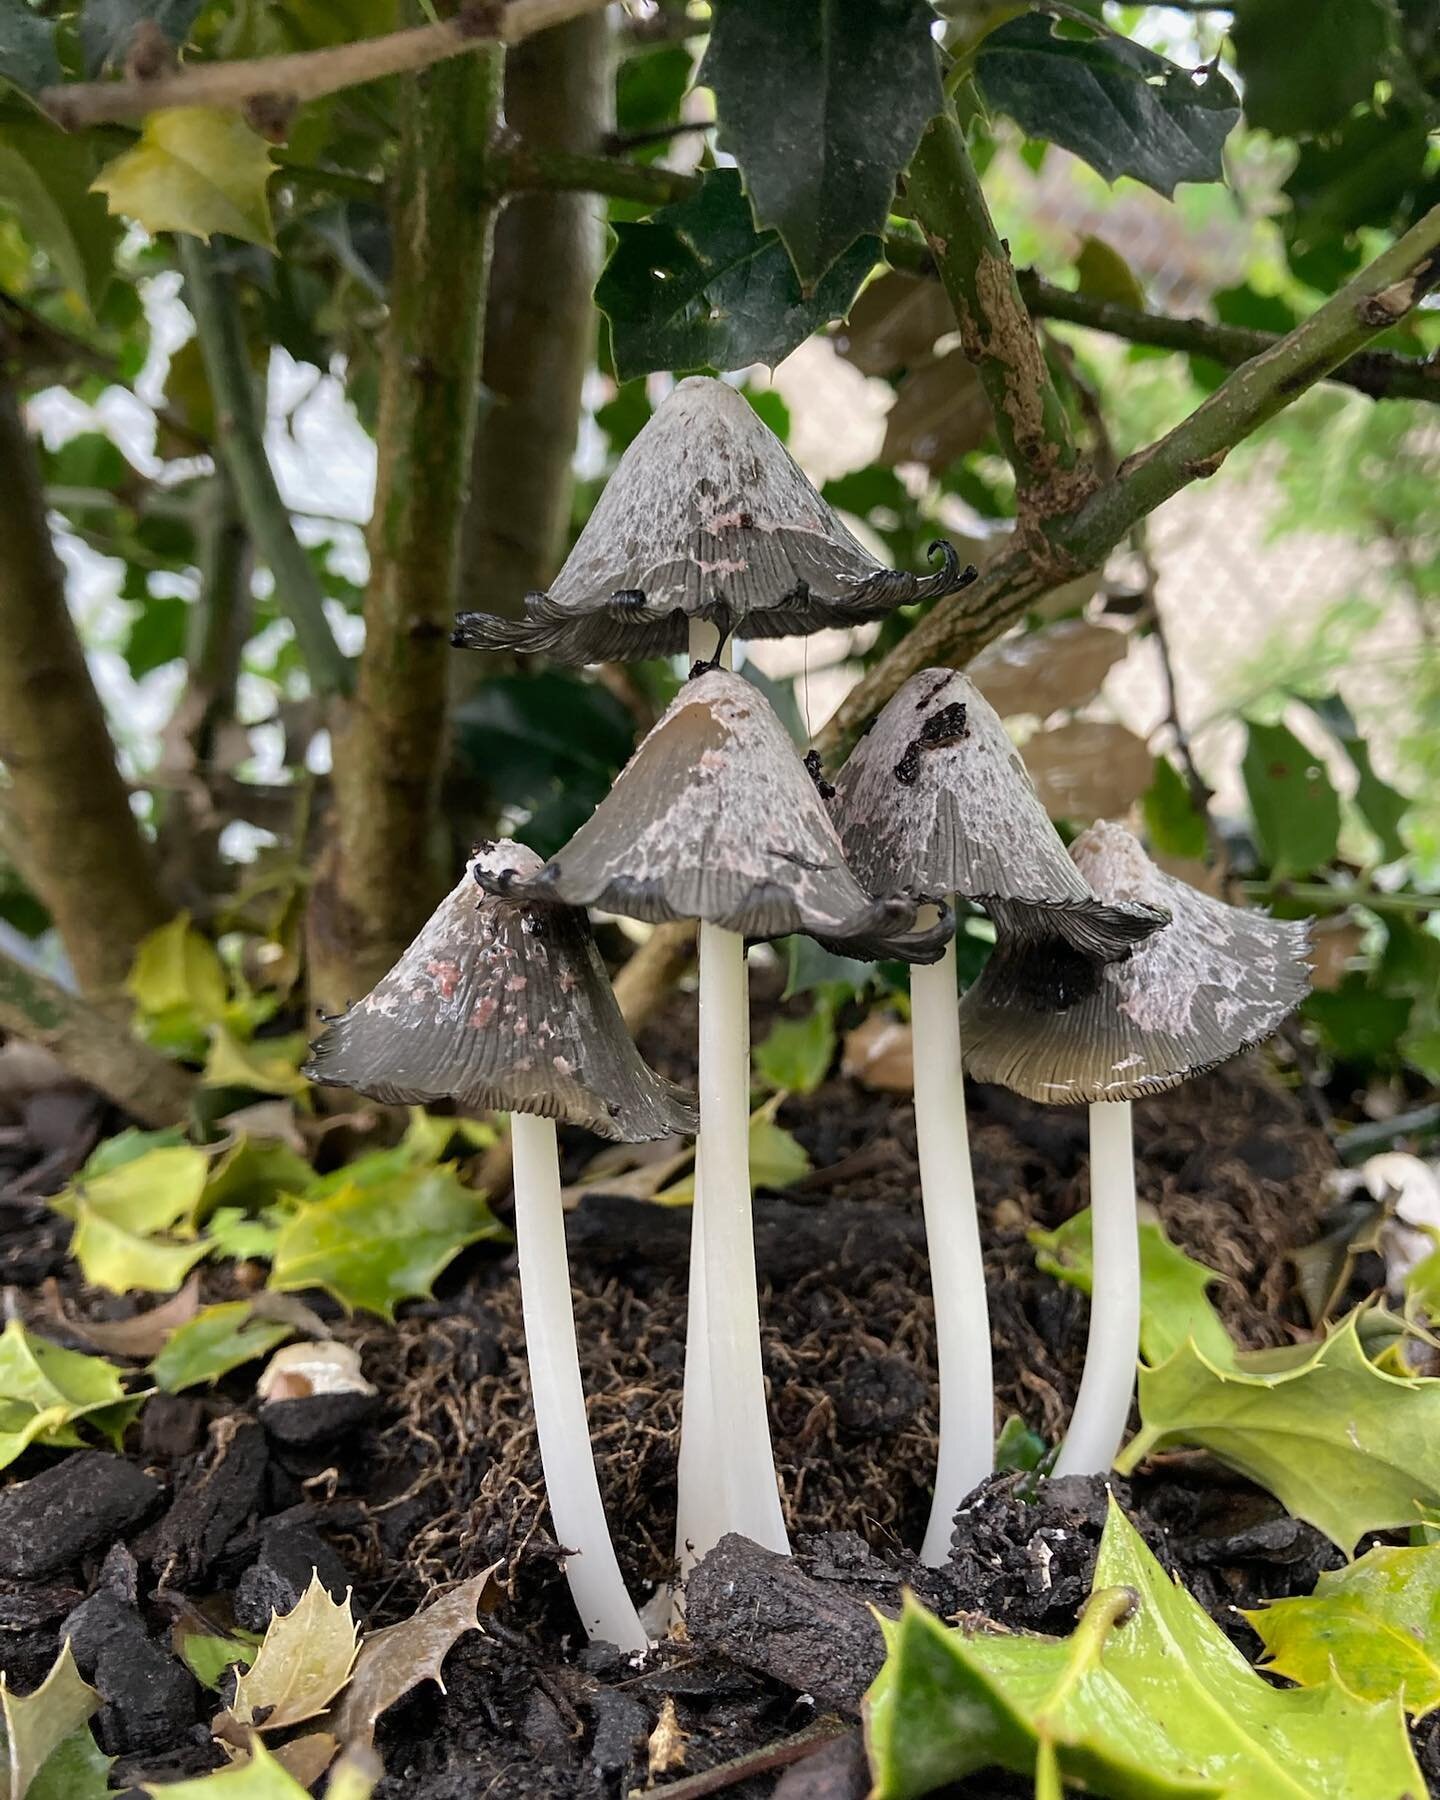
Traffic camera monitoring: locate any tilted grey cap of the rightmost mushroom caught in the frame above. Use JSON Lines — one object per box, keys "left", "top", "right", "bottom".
{"left": 959, "top": 824, "right": 1310, "bottom": 1102}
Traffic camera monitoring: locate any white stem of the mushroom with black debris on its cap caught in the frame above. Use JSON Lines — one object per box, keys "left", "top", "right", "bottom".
{"left": 911, "top": 914, "right": 995, "bottom": 1568}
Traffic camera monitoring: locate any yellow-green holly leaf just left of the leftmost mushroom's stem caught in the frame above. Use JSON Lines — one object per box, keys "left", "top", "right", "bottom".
{"left": 270, "top": 1168, "right": 508, "bottom": 1319}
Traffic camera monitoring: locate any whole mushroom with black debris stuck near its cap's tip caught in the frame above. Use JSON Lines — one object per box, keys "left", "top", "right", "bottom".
{"left": 832, "top": 670, "right": 1166, "bottom": 1566}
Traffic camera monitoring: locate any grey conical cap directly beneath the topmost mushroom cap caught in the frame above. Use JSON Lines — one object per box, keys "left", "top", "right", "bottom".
{"left": 489, "top": 668, "right": 949, "bottom": 961}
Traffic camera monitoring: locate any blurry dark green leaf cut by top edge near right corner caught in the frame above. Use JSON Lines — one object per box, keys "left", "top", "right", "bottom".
{"left": 1231, "top": 0, "right": 1393, "bottom": 137}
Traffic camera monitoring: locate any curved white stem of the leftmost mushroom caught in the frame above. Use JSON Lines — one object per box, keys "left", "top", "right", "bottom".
{"left": 509, "top": 1112, "right": 650, "bottom": 1651}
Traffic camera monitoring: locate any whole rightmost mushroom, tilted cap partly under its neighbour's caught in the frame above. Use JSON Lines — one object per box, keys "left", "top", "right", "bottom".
{"left": 959, "top": 823, "right": 1309, "bottom": 1474}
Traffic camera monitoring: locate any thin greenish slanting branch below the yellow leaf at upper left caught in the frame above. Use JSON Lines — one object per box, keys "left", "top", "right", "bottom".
{"left": 176, "top": 244, "right": 353, "bottom": 695}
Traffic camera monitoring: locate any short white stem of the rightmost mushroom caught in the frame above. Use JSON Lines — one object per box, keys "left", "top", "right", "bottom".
{"left": 1055, "top": 1100, "right": 1139, "bottom": 1474}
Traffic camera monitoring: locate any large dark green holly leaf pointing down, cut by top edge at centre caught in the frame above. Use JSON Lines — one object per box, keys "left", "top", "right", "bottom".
{"left": 697, "top": 0, "right": 945, "bottom": 293}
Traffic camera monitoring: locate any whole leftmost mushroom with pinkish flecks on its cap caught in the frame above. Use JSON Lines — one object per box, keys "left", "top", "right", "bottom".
{"left": 304, "top": 839, "right": 697, "bottom": 1651}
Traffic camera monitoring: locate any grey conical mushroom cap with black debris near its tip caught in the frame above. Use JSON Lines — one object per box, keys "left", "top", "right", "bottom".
{"left": 832, "top": 670, "right": 1166, "bottom": 963}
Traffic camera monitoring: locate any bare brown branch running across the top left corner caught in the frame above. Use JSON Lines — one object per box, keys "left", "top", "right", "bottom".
{"left": 40, "top": 0, "right": 607, "bottom": 131}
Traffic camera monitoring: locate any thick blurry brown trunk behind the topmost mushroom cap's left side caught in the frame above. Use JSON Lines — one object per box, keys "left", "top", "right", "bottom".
{"left": 455, "top": 13, "right": 614, "bottom": 637}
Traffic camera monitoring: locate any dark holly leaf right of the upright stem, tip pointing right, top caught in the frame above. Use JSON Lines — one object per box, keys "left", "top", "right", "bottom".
{"left": 976, "top": 13, "right": 1240, "bottom": 200}
